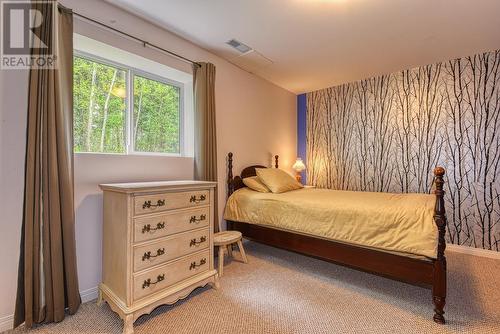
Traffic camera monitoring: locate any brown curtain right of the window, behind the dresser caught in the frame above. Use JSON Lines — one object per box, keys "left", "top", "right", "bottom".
{"left": 193, "top": 63, "right": 219, "bottom": 232}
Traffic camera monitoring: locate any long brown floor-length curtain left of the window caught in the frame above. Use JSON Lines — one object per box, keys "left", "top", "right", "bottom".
{"left": 14, "top": 2, "right": 80, "bottom": 328}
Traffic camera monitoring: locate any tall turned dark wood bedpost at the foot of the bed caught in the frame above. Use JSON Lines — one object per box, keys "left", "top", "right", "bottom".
{"left": 432, "top": 167, "right": 446, "bottom": 324}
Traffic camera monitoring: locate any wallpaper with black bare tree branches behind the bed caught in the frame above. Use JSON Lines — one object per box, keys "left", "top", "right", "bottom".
{"left": 306, "top": 50, "right": 500, "bottom": 251}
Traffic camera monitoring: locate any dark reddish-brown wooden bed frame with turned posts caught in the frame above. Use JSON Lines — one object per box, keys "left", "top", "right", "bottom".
{"left": 227, "top": 153, "right": 446, "bottom": 324}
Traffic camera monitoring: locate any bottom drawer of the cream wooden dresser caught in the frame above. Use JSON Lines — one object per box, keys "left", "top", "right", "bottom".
{"left": 133, "top": 249, "right": 210, "bottom": 300}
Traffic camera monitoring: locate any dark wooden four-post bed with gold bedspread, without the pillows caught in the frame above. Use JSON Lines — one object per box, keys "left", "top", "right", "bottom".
{"left": 224, "top": 153, "right": 446, "bottom": 324}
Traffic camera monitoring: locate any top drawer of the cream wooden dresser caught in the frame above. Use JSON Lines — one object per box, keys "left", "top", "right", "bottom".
{"left": 134, "top": 190, "right": 210, "bottom": 215}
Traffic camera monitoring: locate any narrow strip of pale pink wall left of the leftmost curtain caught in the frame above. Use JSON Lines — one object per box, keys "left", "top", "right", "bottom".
{"left": 0, "top": 70, "right": 28, "bottom": 331}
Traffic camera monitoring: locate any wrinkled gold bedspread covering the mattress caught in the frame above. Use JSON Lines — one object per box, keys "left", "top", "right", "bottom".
{"left": 224, "top": 188, "right": 438, "bottom": 258}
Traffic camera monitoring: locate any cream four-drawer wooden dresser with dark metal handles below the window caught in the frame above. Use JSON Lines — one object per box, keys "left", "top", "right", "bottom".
{"left": 98, "top": 181, "right": 218, "bottom": 334}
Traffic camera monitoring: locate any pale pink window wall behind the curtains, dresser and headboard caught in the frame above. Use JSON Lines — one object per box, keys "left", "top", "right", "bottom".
{"left": 0, "top": 0, "right": 296, "bottom": 324}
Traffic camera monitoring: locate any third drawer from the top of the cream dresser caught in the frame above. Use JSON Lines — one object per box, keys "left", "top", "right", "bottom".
{"left": 133, "top": 228, "right": 210, "bottom": 271}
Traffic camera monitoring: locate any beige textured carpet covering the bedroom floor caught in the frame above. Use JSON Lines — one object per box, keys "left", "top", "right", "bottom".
{"left": 7, "top": 242, "right": 500, "bottom": 334}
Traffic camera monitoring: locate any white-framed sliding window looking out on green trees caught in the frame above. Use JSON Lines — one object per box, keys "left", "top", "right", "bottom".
{"left": 73, "top": 52, "right": 184, "bottom": 155}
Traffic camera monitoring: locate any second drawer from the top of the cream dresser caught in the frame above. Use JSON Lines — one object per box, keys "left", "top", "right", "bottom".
{"left": 134, "top": 207, "right": 211, "bottom": 242}
